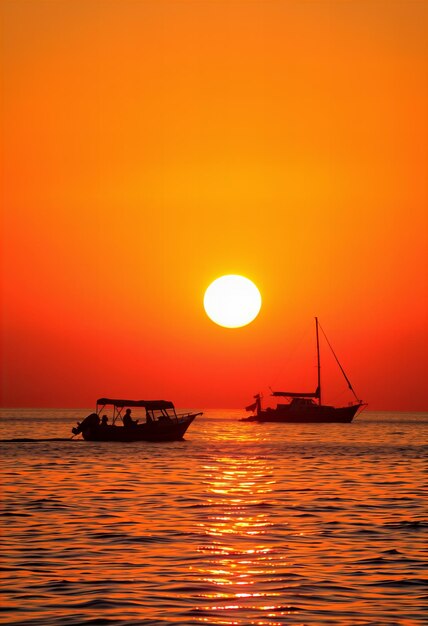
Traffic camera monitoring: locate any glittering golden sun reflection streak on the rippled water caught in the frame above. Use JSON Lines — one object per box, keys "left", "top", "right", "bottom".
{"left": 192, "top": 457, "right": 295, "bottom": 626}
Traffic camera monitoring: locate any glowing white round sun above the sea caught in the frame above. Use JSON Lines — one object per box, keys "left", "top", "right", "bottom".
{"left": 204, "top": 274, "right": 262, "bottom": 328}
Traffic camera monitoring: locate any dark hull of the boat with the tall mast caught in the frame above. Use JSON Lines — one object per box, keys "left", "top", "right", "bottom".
{"left": 246, "top": 403, "right": 363, "bottom": 424}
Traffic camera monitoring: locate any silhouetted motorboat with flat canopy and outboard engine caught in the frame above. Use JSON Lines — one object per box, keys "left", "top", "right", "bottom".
{"left": 72, "top": 398, "right": 202, "bottom": 441}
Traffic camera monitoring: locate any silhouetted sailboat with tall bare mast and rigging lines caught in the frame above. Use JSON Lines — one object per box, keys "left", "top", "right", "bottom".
{"left": 242, "top": 317, "right": 366, "bottom": 423}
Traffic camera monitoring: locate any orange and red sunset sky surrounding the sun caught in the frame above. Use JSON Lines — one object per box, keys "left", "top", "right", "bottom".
{"left": 1, "top": 0, "right": 428, "bottom": 410}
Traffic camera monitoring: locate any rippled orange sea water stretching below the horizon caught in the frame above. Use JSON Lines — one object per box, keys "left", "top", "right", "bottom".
{"left": 0, "top": 409, "right": 428, "bottom": 626}
